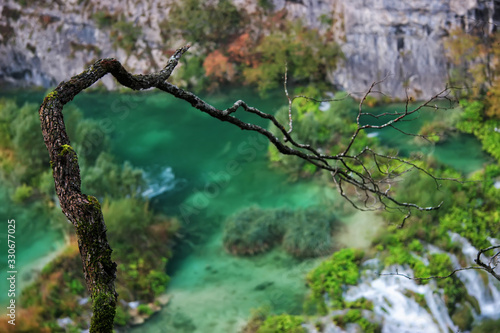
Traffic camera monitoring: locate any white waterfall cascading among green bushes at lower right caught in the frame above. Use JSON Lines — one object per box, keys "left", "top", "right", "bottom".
{"left": 332, "top": 233, "right": 500, "bottom": 333}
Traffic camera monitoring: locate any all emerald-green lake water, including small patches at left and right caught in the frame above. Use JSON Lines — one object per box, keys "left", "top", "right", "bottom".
{"left": 0, "top": 89, "right": 492, "bottom": 333}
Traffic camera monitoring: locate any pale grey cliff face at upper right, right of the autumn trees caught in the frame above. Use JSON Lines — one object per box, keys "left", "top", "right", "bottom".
{"left": 275, "top": 0, "right": 500, "bottom": 98}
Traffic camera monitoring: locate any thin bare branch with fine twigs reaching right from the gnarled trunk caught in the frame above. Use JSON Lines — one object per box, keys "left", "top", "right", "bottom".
{"left": 157, "top": 76, "right": 455, "bottom": 211}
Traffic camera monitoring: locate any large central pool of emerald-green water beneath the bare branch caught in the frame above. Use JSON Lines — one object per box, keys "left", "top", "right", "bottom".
{"left": 67, "top": 92, "right": 372, "bottom": 332}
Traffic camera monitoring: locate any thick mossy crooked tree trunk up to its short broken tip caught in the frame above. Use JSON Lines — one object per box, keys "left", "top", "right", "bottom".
{"left": 39, "top": 47, "right": 188, "bottom": 333}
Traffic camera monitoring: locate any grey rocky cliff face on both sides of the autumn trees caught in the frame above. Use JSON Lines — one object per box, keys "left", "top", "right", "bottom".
{"left": 0, "top": 0, "right": 500, "bottom": 98}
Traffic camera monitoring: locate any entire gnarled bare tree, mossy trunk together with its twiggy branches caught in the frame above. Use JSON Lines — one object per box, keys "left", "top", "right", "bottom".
{"left": 39, "top": 46, "right": 498, "bottom": 333}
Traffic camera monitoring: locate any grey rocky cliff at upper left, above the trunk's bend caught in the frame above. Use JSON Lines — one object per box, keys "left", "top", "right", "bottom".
{"left": 0, "top": 0, "right": 173, "bottom": 89}
